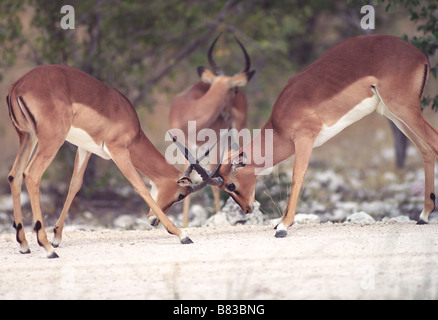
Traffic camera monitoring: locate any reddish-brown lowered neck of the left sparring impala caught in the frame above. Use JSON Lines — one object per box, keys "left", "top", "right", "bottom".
{"left": 129, "top": 130, "right": 181, "bottom": 184}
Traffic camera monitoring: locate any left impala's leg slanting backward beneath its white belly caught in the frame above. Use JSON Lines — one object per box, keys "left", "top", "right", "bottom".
{"left": 52, "top": 147, "right": 91, "bottom": 248}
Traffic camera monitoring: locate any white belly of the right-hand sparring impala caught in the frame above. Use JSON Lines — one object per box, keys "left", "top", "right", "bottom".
{"left": 313, "top": 95, "right": 380, "bottom": 148}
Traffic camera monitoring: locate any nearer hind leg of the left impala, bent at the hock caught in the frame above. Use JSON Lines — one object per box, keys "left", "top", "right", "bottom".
{"left": 24, "top": 139, "right": 64, "bottom": 258}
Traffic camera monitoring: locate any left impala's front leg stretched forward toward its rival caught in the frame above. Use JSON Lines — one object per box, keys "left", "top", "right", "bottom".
{"left": 108, "top": 146, "right": 192, "bottom": 244}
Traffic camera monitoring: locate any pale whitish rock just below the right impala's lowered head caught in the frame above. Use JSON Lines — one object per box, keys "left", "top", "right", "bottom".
{"left": 203, "top": 197, "right": 264, "bottom": 227}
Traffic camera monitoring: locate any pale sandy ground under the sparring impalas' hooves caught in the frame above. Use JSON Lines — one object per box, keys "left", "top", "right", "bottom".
{"left": 0, "top": 222, "right": 438, "bottom": 299}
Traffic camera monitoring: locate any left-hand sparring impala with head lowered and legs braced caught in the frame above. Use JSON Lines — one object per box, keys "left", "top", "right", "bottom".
{"left": 6, "top": 65, "right": 209, "bottom": 258}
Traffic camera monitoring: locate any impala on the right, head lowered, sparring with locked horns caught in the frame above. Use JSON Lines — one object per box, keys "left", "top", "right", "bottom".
{"left": 177, "top": 35, "right": 438, "bottom": 238}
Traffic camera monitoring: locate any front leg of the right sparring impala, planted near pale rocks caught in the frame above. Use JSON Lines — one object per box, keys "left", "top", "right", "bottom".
{"left": 275, "top": 137, "right": 314, "bottom": 238}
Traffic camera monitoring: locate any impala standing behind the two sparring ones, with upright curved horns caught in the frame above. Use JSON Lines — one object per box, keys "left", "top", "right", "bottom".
{"left": 169, "top": 34, "right": 255, "bottom": 226}
